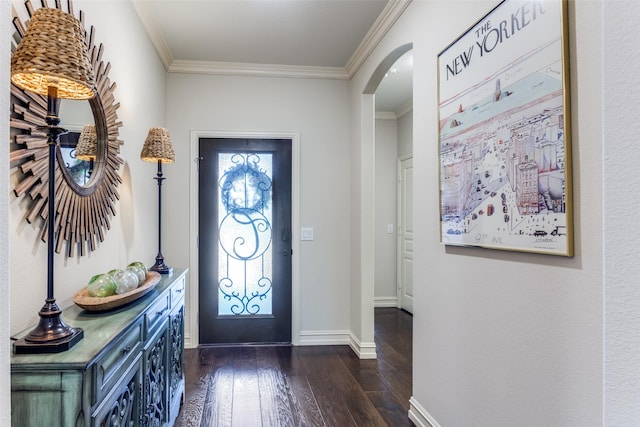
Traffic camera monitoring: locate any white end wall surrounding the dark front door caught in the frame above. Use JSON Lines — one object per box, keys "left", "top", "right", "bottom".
{"left": 163, "top": 74, "right": 352, "bottom": 345}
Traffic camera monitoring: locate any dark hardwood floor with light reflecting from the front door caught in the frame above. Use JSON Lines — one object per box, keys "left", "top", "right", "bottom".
{"left": 176, "top": 308, "right": 413, "bottom": 427}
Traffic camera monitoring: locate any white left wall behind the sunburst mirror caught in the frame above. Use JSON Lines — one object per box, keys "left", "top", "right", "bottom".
{"left": 8, "top": 0, "right": 166, "bottom": 332}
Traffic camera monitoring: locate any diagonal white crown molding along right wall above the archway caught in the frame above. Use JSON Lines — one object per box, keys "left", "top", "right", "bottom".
{"left": 345, "top": 0, "right": 412, "bottom": 78}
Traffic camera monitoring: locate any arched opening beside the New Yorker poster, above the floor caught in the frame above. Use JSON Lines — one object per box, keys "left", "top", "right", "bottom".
{"left": 374, "top": 49, "right": 413, "bottom": 312}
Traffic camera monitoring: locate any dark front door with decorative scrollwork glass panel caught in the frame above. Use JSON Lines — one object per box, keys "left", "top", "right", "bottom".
{"left": 198, "top": 138, "right": 292, "bottom": 344}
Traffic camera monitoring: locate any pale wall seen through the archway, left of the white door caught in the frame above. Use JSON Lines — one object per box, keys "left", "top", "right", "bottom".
{"left": 374, "top": 118, "right": 398, "bottom": 307}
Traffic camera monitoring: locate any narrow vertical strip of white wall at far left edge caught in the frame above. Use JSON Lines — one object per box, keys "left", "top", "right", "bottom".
{"left": 0, "top": 0, "right": 11, "bottom": 426}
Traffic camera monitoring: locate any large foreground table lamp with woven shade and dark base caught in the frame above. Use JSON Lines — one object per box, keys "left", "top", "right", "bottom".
{"left": 11, "top": 7, "right": 95, "bottom": 353}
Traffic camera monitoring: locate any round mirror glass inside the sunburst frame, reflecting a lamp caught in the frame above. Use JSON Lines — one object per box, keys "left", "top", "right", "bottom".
{"left": 58, "top": 99, "right": 106, "bottom": 188}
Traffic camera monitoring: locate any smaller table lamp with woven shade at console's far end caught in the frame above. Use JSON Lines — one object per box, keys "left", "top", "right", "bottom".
{"left": 140, "top": 128, "right": 176, "bottom": 274}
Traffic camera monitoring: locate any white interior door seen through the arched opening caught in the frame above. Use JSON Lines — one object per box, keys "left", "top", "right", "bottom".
{"left": 397, "top": 157, "right": 413, "bottom": 313}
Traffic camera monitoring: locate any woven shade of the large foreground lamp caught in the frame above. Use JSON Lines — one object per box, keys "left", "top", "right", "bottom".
{"left": 11, "top": 7, "right": 95, "bottom": 99}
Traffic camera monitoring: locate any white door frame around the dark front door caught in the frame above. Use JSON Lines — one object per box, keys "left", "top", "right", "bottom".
{"left": 189, "top": 130, "right": 300, "bottom": 348}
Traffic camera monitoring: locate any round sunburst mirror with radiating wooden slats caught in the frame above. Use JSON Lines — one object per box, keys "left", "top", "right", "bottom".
{"left": 10, "top": 0, "right": 124, "bottom": 257}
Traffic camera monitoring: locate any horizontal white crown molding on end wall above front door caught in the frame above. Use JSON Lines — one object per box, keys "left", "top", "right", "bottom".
{"left": 167, "top": 60, "right": 351, "bottom": 80}
